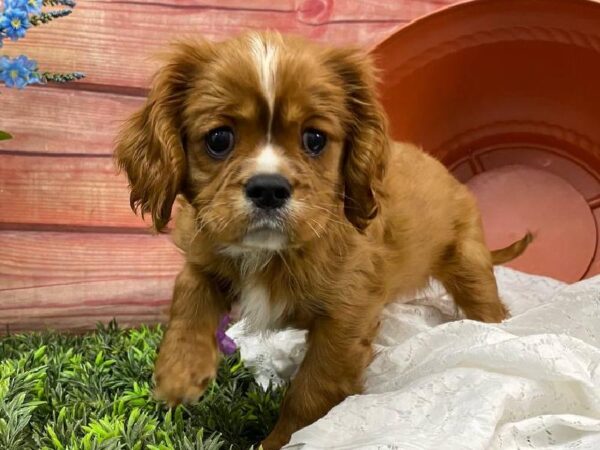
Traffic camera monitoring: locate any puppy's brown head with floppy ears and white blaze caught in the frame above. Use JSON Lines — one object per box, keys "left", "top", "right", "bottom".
{"left": 115, "top": 33, "right": 388, "bottom": 250}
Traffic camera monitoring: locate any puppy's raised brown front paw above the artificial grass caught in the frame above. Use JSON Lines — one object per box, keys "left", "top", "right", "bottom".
{"left": 154, "top": 331, "right": 218, "bottom": 407}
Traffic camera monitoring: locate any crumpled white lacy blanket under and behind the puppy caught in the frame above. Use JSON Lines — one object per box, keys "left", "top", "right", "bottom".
{"left": 229, "top": 268, "right": 600, "bottom": 450}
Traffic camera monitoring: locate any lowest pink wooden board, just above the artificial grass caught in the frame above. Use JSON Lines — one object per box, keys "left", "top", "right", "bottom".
{"left": 0, "top": 231, "right": 183, "bottom": 331}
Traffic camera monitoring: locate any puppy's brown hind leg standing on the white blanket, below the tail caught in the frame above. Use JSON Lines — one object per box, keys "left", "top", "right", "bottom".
{"left": 437, "top": 240, "right": 508, "bottom": 322}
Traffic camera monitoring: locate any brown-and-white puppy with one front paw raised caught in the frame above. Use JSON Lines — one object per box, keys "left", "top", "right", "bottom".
{"left": 115, "top": 33, "right": 531, "bottom": 449}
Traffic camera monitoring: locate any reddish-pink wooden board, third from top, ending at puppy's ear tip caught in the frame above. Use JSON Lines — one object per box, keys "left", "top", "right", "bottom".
{"left": 0, "top": 154, "right": 148, "bottom": 228}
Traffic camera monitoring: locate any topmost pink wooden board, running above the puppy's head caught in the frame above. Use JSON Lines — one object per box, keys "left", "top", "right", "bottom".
{"left": 3, "top": 0, "right": 455, "bottom": 92}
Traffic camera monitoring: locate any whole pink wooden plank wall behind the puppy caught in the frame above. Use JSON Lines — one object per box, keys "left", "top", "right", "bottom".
{"left": 0, "top": 0, "right": 456, "bottom": 332}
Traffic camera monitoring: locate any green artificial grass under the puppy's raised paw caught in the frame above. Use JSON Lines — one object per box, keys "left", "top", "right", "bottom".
{"left": 0, "top": 323, "right": 283, "bottom": 450}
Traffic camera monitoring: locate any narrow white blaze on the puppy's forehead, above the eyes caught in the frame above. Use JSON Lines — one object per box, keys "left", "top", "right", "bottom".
{"left": 250, "top": 34, "right": 279, "bottom": 133}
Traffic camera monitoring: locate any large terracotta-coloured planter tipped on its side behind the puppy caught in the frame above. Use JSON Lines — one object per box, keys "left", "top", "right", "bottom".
{"left": 373, "top": 0, "right": 600, "bottom": 281}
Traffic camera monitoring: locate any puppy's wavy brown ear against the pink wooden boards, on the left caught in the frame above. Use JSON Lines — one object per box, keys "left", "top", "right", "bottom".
{"left": 114, "top": 42, "right": 211, "bottom": 231}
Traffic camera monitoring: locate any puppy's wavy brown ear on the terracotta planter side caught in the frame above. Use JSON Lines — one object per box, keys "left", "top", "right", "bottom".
{"left": 327, "top": 49, "right": 389, "bottom": 231}
